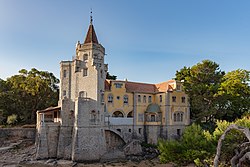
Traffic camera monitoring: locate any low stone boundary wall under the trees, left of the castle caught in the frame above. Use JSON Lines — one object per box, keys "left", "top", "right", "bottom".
{"left": 0, "top": 128, "right": 36, "bottom": 141}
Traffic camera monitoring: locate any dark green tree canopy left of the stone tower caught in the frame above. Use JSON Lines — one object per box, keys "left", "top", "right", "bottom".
{"left": 0, "top": 68, "right": 59, "bottom": 123}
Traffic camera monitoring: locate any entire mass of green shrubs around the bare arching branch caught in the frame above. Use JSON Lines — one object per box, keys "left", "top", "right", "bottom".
{"left": 158, "top": 116, "right": 250, "bottom": 166}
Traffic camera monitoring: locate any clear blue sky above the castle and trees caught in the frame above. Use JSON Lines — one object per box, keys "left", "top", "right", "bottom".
{"left": 0, "top": 0, "right": 250, "bottom": 83}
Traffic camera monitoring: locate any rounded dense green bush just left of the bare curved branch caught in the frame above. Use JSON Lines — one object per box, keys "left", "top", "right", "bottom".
{"left": 158, "top": 124, "right": 216, "bottom": 165}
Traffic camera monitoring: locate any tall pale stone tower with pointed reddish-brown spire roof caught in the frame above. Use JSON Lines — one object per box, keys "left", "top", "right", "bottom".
{"left": 58, "top": 16, "right": 108, "bottom": 161}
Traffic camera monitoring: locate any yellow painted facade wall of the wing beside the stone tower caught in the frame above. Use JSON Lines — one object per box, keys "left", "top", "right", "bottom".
{"left": 104, "top": 81, "right": 190, "bottom": 125}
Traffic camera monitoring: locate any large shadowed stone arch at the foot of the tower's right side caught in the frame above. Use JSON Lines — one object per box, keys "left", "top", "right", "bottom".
{"left": 105, "top": 130, "right": 126, "bottom": 151}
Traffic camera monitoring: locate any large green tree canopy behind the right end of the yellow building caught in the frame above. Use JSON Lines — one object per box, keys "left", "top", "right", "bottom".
{"left": 176, "top": 60, "right": 250, "bottom": 122}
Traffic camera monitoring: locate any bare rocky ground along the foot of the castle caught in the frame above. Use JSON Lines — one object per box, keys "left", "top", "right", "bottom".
{"left": 0, "top": 139, "right": 194, "bottom": 167}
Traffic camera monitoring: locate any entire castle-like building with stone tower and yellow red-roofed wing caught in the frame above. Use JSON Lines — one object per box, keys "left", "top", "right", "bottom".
{"left": 36, "top": 17, "right": 190, "bottom": 161}
